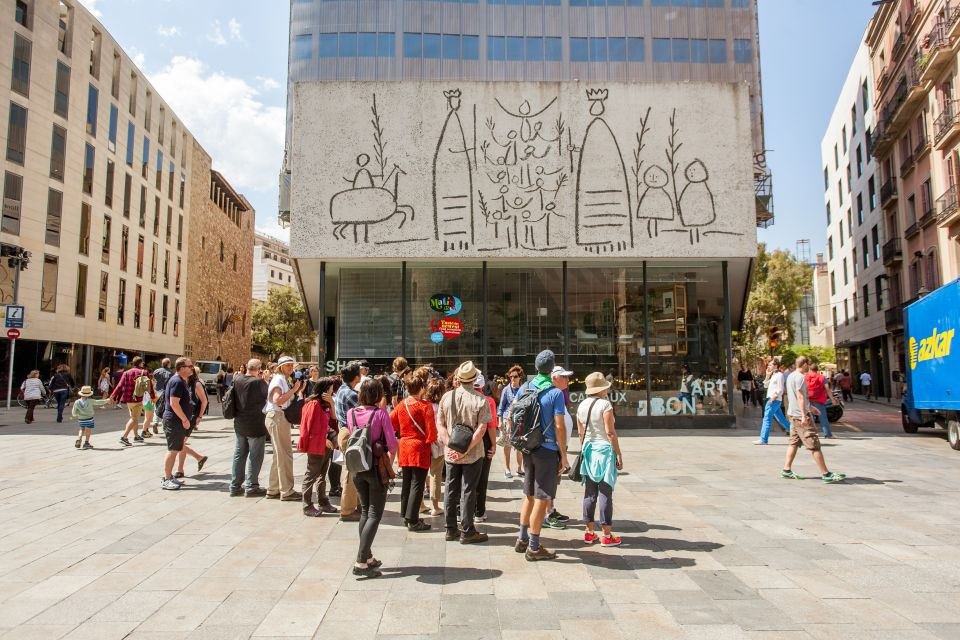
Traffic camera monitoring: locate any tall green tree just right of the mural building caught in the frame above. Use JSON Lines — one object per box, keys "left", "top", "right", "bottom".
{"left": 736, "top": 243, "right": 813, "bottom": 363}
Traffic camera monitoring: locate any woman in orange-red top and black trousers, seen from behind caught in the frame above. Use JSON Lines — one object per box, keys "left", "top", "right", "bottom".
{"left": 390, "top": 367, "right": 437, "bottom": 531}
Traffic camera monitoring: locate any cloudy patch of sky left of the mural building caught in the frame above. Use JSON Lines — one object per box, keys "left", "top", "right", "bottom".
{"left": 80, "top": 0, "right": 289, "bottom": 239}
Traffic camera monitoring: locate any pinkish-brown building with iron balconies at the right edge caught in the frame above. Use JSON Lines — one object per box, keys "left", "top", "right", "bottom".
{"left": 866, "top": 0, "right": 960, "bottom": 398}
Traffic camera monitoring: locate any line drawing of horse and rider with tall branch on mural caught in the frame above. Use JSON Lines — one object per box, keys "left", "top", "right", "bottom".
{"left": 330, "top": 94, "right": 415, "bottom": 244}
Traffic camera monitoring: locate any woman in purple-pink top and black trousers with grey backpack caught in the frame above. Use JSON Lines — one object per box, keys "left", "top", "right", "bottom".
{"left": 346, "top": 378, "right": 397, "bottom": 578}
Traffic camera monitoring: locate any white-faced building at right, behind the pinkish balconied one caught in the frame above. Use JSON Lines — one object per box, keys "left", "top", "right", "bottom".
{"left": 820, "top": 38, "right": 898, "bottom": 395}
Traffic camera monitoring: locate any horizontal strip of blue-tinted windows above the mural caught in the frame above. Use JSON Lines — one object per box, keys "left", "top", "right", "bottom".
{"left": 293, "top": 32, "right": 753, "bottom": 64}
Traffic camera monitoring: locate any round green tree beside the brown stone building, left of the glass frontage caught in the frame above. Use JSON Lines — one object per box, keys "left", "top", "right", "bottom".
{"left": 251, "top": 287, "right": 315, "bottom": 360}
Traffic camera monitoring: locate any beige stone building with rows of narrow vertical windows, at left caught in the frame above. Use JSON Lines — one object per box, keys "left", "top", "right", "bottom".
{"left": 0, "top": 0, "right": 249, "bottom": 380}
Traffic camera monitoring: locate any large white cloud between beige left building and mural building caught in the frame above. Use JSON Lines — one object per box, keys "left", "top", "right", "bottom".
{"left": 150, "top": 56, "right": 286, "bottom": 198}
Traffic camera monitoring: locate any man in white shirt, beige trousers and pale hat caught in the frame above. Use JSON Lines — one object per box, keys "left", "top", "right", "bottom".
{"left": 264, "top": 356, "right": 305, "bottom": 502}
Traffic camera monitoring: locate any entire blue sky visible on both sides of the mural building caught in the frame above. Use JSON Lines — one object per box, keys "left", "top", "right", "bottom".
{"left": 81, "top": 0, "right": 874, "bottom": 252}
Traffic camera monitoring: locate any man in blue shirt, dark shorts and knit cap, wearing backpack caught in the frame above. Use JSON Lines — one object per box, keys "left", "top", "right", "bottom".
{"left": 514, "top": 351, "right": 568, "bottom": 561}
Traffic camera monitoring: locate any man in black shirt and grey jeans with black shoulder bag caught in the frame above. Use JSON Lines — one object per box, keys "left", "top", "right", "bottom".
{"left": 230, "top": 358, "right": 267, "bottom": 498}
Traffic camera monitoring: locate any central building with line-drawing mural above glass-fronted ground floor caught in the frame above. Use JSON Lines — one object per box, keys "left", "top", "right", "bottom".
{"left": 281, "top": 0, "right": 770, "bottom": 426}
